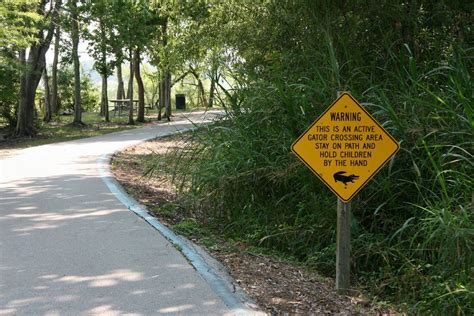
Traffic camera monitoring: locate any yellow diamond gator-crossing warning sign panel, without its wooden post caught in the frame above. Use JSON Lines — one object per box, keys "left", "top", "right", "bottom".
{"left": 291, "top": 93, "right": 400, "bottom": 202}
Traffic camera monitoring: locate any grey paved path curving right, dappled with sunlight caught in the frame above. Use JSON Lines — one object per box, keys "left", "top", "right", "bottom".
{"left": 0, "top": 110, "right": 250, "bottom": 315}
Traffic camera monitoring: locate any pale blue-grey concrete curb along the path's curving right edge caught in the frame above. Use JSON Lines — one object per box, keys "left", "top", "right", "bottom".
{"left": 97, "top": 131, "right": 266, "bottom": 315}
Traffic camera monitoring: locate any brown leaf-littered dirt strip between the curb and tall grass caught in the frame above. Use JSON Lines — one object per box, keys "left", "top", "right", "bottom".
{"left": 112, "top": 136, "right": 390, "bottom": 315}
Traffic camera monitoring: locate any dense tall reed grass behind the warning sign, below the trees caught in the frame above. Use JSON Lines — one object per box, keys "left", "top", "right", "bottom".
{"left": 158, "top": 44, "right": 474, "bottom": 315}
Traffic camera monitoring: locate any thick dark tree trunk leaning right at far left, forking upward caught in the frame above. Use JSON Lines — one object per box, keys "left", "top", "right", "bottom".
{"left": 15, "top": 0, "right": 61, "bottom": 136}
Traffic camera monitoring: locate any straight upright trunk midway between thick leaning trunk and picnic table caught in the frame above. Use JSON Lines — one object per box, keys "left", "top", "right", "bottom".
{"left": 69, "top": 0, "right": 84, "bottom": 125}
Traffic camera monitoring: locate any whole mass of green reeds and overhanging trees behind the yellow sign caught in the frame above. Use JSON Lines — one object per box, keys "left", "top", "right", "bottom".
{"left": 158, "top": 0, "right": 474, "bottom": 315}
